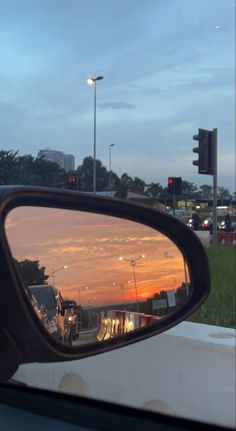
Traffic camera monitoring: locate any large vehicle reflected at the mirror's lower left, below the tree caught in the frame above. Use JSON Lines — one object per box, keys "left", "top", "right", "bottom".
{"left": 28, "top": 285, "right": 72, "bottom": 341}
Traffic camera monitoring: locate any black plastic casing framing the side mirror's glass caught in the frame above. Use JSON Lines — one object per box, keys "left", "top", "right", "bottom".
{"left": 0, "top": 186, "right": 210, "bottom": 379}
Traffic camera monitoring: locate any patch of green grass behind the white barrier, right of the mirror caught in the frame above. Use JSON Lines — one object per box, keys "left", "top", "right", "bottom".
{"left": 188, "top": 246, "right": 236, "bottom": 328}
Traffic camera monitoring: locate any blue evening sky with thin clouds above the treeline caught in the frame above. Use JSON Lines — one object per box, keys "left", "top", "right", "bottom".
{"left": 0, "top": 0, "right": 235, "bottom": 192}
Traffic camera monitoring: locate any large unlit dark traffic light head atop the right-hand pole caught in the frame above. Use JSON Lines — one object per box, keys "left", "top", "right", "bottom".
{"left": 193, "top": 129, "right": 215, "bottom": 175}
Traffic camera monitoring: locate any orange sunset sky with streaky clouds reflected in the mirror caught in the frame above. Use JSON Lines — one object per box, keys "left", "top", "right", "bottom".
{"left": 6, "top": 207, "right": 188, "bottom": 306}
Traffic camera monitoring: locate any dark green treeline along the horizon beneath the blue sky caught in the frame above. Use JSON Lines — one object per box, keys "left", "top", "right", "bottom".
{"left": 0, "top": 150, "right": 231, "bottom": 202}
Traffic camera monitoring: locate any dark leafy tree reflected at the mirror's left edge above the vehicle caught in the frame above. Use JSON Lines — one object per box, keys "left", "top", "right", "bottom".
{"left": 14, "top": 259, "right": 49, "bottom": 286}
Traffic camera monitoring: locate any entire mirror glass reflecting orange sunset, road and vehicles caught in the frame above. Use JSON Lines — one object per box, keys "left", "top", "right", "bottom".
{"left": 5, "top": 207, "right": 191, "bottom": 346}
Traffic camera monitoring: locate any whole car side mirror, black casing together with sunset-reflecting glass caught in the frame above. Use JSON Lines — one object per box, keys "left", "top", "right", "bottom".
{"left": 0, "top": 187, "right": 210, "bottom": 370}
